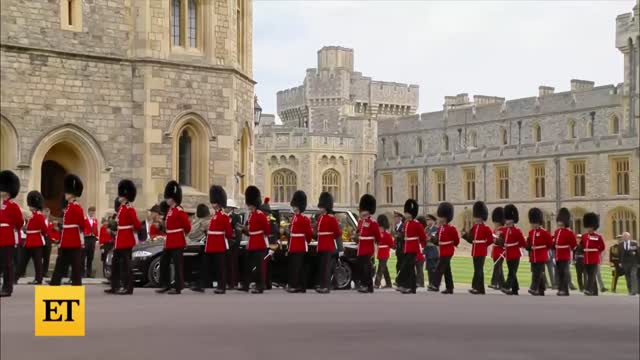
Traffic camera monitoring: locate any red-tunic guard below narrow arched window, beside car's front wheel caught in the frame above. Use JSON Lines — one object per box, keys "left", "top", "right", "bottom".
{"left": 156, "top": 180, "right": 191, "bottom": 295}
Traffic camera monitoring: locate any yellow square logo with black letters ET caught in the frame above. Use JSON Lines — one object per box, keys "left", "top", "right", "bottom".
{"left": 34, "top": 286, "right": 85, "bottom": 336}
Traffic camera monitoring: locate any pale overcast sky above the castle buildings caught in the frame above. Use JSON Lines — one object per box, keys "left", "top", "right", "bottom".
{"left": 253, "top": 0, "right": 635, "bottom": 113}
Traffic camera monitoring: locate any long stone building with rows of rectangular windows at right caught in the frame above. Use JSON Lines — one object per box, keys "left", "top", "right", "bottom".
{"left": 375, "top": 6, "right": 640, "bottom": 239}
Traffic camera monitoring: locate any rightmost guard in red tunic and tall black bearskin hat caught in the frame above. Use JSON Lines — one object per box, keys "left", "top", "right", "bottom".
{"left": 580, "top": 212, "right": 605, "bottom": 296}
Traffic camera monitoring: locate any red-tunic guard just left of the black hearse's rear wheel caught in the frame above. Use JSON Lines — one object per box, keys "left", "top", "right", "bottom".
{"left": 316, "top": 192, "right": 342, "bottom": 294}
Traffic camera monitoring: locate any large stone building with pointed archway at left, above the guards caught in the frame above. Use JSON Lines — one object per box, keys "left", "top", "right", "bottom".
{"left": 0, "top": 0, "right": 254, "bottom": 214}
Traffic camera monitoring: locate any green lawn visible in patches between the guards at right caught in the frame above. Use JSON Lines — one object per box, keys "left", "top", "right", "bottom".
{"left": 382, "top": 256, "right": 627, "bottom": 294}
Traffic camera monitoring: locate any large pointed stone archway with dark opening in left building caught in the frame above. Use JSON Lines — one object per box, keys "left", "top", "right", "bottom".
{"left": 29, "top": 124, "right": 109, "bottom": 216}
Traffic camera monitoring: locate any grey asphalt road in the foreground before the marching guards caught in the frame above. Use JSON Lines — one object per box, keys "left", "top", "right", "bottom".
{"left": 0, "top": 285, "right": 640, "bottom": 360}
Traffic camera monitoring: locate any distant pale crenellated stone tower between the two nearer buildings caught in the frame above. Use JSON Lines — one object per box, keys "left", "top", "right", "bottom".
{"left": 255, "top": 46, "right": 418, "bottom": 207}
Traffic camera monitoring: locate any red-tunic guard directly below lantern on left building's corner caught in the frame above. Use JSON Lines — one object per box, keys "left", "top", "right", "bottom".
{"left": 240, "top": 185, "right": 271, "bottom": 294}
